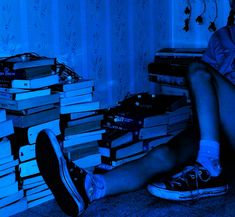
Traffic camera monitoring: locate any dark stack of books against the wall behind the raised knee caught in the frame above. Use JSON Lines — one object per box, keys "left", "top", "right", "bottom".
{"left": 148, "top": 48, "right": 205, "bottom": 102}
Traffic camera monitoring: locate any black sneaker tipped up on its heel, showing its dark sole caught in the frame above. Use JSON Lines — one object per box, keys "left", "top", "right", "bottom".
{"left": 36, "top": 129, "right": 89, "bottom": 216}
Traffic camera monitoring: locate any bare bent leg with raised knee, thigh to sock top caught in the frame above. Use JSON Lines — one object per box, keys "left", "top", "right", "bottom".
{"left": 189, "top": 63, "right": 235, "bottom": 148}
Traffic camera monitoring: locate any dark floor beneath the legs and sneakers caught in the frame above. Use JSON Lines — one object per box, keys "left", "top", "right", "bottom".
{"left": 11, "top": 182, "right": 235, "bottom": 217}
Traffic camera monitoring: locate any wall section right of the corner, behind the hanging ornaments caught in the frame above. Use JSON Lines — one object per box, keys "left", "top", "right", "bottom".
{"left": 171, "top": 0, "right": 229, "bottom": 47}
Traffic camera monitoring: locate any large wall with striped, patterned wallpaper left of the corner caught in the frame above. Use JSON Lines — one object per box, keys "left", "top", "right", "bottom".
{"left": 0, "top": 0, "right": 171, "bottom": 107}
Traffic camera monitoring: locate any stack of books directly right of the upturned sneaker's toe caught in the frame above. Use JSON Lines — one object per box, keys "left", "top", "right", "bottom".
{"left": 53, "top": 79, "right": 105, "bottom": 170}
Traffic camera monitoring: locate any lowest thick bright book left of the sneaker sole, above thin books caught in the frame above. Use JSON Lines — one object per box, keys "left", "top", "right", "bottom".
{"left": 19, "top": 160, "right": 39, "bottom": 178}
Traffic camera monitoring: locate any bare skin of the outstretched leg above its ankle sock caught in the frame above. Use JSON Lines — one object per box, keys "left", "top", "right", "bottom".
{"left": 104, "top": 126, "right": 198, "bottom": 195}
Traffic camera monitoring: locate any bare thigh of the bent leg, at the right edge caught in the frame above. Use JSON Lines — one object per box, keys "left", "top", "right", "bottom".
{"left": 207, "top": 65, "right": 235, "bottom": 149}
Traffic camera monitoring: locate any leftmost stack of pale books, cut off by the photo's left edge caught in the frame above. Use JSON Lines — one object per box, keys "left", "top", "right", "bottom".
{"left": 0, "top": 109, "right": 27, "bottom": 216}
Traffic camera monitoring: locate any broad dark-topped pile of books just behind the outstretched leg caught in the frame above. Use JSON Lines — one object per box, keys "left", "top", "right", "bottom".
{"left": 99, "top": 93, "right": 191, "bottom": 168}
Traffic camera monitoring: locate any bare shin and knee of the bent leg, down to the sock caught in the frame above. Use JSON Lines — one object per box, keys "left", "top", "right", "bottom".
{"left": 188, "top": 63, "right": 219, "bottom": 141}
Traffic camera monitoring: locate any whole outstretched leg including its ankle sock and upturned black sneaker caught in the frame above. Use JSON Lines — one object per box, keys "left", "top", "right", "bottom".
{"left": 36, "top": 125, "right": 198, "bottom": 216}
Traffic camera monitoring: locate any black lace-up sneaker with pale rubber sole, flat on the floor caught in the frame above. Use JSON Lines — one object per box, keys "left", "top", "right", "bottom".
{"left": 148, "top": 163, "right": 228, "bottom": 201}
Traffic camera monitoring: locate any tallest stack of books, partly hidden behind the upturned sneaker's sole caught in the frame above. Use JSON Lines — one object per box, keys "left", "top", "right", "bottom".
{"left": 0, "top": 56, "right": 60, "bottom": 207}
